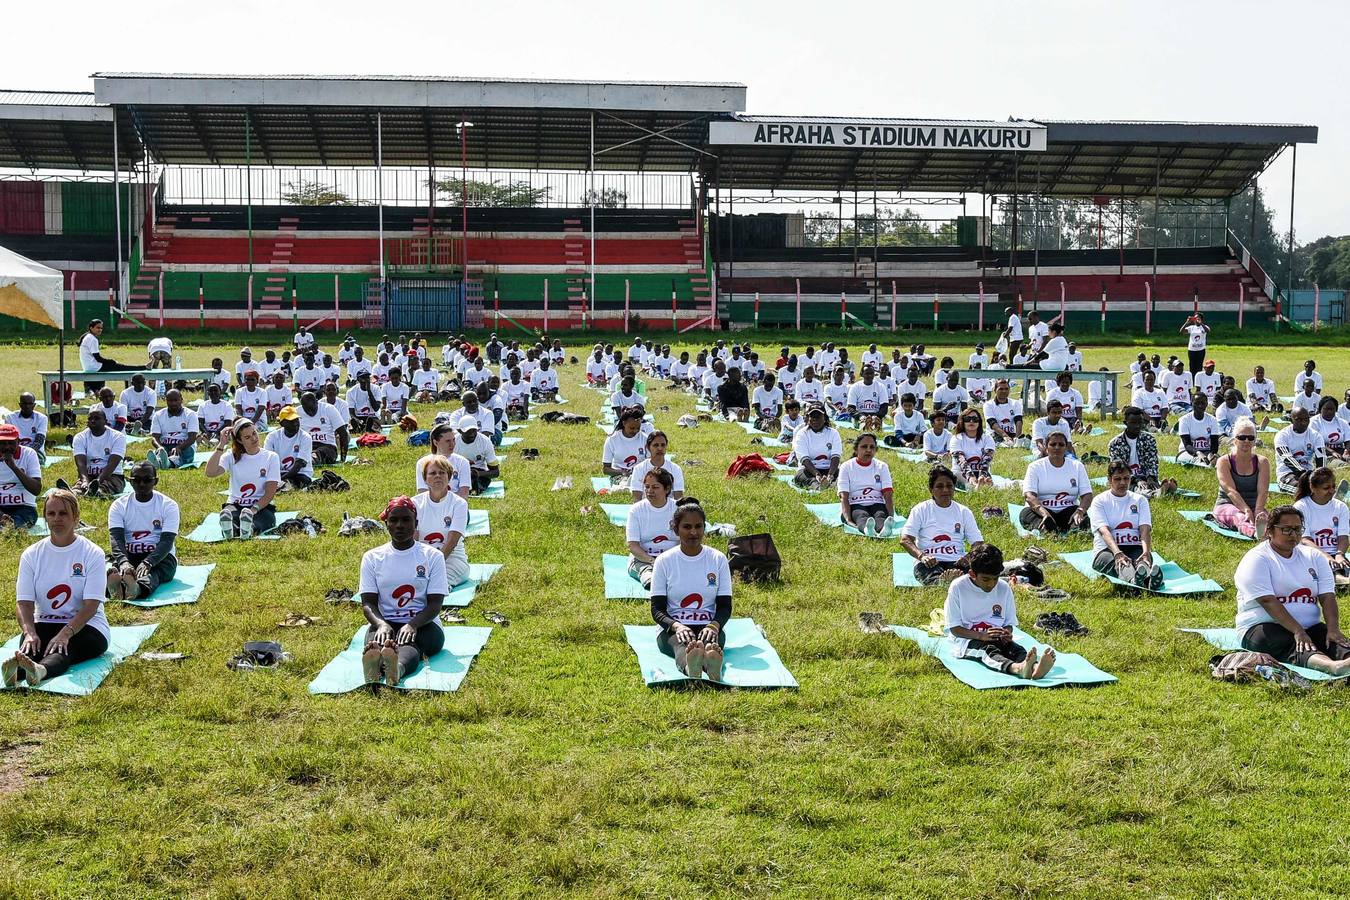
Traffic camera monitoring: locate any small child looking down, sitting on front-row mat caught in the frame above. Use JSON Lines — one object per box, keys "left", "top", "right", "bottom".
{"left": 945, "top": 544, "right": 1054, "bottom": 680}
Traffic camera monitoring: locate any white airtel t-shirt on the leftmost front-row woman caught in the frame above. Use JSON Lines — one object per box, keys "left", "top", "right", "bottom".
{"left": 15, "top": 534, "right": 109, "bottom": 637}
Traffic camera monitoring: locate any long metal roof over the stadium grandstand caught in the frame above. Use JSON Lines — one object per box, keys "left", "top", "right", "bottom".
{"left": 0, "top": 73, "right": 1318, "bottom": 198}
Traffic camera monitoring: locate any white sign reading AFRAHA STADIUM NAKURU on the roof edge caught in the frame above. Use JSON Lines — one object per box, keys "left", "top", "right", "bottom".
{"left": 707, "top": 119, "right": 1045, "bottom": 152}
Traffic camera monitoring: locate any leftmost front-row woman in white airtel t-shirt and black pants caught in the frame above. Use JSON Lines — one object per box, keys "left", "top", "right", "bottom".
{"left": 0, "top": 488, "right": 111, "bottom": 687}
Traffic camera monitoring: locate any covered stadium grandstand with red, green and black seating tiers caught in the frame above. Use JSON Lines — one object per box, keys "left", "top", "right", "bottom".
{"left": 0, "top": 73, "right": 1317, "bottom": 333}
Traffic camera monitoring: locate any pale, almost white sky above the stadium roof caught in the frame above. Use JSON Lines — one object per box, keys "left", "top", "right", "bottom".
{"left": 0, "top": 0, "right": 1350, "bottom": 242}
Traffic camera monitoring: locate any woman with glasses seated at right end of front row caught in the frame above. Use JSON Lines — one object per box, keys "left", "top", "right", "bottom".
{"left": 1234, "top": 506, "right": 1350, "bottom": 675}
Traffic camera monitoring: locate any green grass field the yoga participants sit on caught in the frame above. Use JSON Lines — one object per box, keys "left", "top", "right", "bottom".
{"left": 0, "top": 335, "right": 1350, "bottom": 897}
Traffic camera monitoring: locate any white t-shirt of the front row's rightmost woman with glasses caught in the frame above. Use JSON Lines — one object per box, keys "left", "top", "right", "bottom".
{"left": 1233, "top": 541, "right": 1335, "bottom": 640}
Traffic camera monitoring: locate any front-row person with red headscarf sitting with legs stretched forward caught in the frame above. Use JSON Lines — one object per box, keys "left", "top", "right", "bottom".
{"left": 359, "top": 497, "right": 450, "bottom": 687}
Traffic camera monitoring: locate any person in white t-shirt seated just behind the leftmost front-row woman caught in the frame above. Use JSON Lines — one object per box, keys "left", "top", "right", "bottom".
{"left": 108, "top": 461, "right": 180, "bottom": 600}
